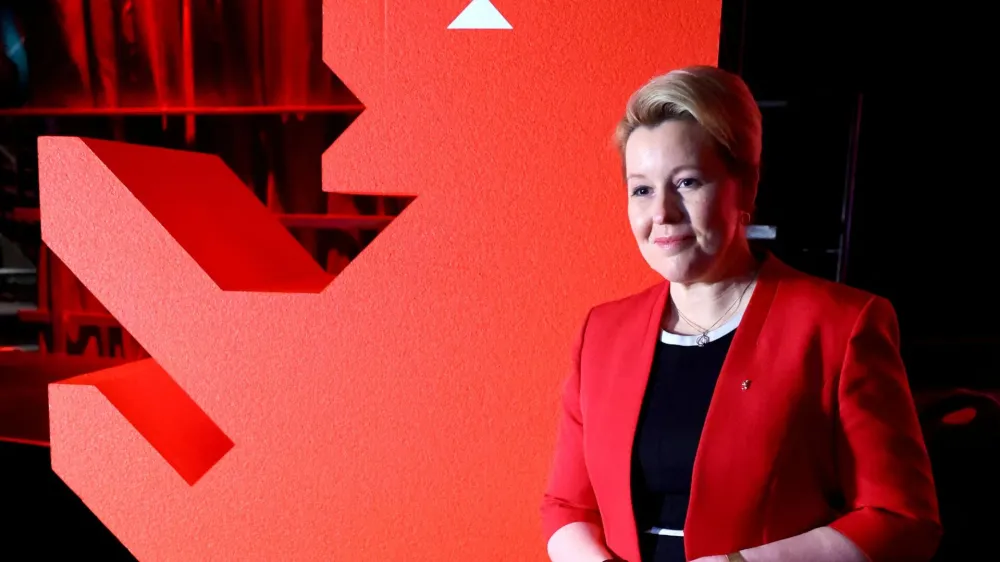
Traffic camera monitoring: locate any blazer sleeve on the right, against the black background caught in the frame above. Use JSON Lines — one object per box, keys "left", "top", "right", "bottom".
{"left": 830, "top": 297, "right": 941, "bottom": 562}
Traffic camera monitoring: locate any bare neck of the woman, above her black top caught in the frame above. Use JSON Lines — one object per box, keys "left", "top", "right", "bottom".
{"left": 664, "top": 246, "right": 758, "bottom": 333}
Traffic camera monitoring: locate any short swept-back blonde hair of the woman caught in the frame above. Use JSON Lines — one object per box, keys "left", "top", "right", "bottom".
{"left": 615, "top": 66, "right": 761, "bottom": 185}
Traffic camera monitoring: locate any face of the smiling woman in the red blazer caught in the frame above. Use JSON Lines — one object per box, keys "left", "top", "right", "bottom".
{"left": 625, "top": 120, "right": 744, "bottom": 284}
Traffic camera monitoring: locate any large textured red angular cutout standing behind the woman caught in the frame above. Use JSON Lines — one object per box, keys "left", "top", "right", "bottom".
{"left": 39, "top": 0, "right": 720, "bottom": 561}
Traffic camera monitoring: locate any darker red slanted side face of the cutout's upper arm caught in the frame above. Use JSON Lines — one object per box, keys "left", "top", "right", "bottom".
{"left": 86, "top": 140, "right": 333, "bottom": 293}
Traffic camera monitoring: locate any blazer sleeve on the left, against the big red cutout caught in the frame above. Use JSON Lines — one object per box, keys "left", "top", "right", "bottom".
{"left": 542, "top": 308, "right": 601, "bottom": 543}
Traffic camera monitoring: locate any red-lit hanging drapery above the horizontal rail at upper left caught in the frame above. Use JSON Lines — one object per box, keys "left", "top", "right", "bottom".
{"left": 53, "top": 0, "right": 333, "bottom": 107}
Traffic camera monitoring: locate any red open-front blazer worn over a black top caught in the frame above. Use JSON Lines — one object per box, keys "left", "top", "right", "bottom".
{"left": 542, "top": 257, "right": 941, "bottom": 562}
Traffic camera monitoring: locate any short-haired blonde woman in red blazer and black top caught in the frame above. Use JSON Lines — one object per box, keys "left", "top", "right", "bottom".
{"left": 542, "top": 67, "right": 941, "bottom": 562}
